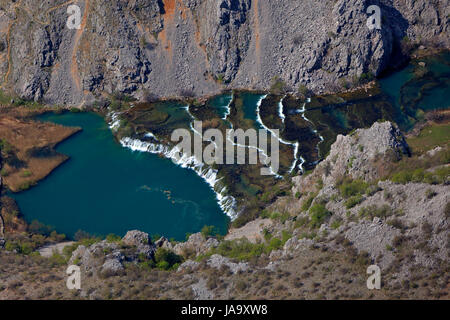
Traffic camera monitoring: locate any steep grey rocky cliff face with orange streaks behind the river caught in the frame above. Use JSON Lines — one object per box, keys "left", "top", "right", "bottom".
{"left": 0, "top": 0, "right": 450, "bottom": 105}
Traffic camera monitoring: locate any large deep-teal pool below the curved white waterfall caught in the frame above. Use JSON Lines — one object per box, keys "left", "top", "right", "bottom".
{"left": 14, "top": 113, "right": 229, "bottom": 240}
